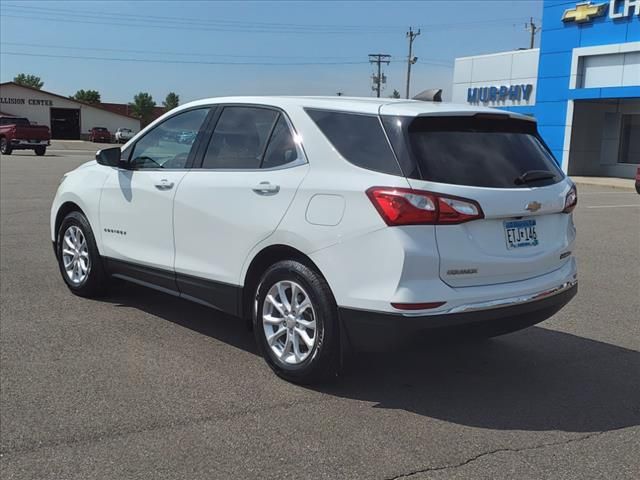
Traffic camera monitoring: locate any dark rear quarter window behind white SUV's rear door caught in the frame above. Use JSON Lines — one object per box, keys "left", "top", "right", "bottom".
{"left": 307, "top": 109, "right": 401, "bottom": 175}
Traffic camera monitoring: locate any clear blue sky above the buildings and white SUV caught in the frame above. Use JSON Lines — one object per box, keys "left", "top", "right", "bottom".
{"left": 0, "top": 0, "right": 542, "bottom": 104}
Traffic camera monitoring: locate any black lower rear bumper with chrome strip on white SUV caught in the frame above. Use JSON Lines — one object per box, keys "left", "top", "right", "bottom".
{"left": 339, "top": 280, "right": 578, "bottom": 351}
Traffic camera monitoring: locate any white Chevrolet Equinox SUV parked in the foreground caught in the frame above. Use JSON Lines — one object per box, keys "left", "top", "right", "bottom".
{"left": 51, "top": 97, "right": 577, "bottom": 382}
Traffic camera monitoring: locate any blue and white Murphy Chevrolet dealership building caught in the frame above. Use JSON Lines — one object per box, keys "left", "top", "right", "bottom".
{"left": 452, "top": 0, "right": 640, "bottom": 178}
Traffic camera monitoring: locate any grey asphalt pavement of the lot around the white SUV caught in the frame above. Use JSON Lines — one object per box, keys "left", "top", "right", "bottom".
{"left": 0, "top": 152, "right": 640, "bottom": 480}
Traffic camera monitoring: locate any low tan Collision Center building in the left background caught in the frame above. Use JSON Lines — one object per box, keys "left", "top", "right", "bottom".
{"left": 0, "top": 82, "right": 140, "bottom": 140}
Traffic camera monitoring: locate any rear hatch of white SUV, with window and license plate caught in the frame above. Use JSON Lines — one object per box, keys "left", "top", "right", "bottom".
{"left": 383, "top": 114, "right": 574, "bottom": 287}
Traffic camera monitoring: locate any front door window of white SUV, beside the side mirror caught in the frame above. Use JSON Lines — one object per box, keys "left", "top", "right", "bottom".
{"left": 130, "top": 108, "right": 209, "bottom": 170}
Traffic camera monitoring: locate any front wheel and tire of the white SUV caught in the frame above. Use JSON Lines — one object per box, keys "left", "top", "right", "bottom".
{"left": 56, "top": 211, "right": 108, "bottom": 298}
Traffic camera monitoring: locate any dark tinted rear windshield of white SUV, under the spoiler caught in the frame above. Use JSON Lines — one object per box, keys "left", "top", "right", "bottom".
{"left": 384, "top": 114, "right": 563, "bottom": 188}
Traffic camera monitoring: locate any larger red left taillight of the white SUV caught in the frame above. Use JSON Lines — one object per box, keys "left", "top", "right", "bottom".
{"left": 367, "top": 187, "right": 484, "bottom": 226}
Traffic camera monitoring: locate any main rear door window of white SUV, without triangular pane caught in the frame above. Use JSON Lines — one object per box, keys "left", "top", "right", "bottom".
{"left": 202, "top": 107, "right": 278, "bottom": 169}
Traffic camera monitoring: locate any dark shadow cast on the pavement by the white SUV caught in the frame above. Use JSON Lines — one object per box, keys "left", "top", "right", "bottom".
{"left": 107, "top": 285, "right": 640, "bottom": 432}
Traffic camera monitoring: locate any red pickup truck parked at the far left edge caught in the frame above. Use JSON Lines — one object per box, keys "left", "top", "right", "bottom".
{"left": 0, "top": 116, "right": 51, "bottom": 156}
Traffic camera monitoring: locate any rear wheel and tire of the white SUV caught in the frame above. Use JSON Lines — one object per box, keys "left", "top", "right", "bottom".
{"left": 253, "top": 260, "right": 340, "bottom": 384}
